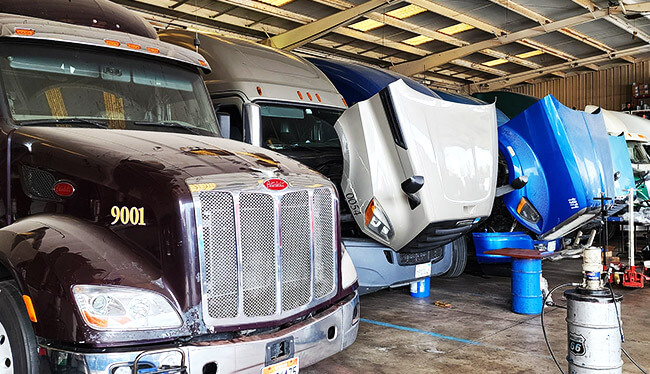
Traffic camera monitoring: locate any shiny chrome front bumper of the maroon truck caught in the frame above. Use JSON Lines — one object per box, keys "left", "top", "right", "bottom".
{"left": 40, "top": 292, "right": 360, "bottom": 374}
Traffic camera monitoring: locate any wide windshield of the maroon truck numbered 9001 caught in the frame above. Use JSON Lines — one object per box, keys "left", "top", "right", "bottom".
{"left": 0, "top": 43, "right": 219, "bottom": 136}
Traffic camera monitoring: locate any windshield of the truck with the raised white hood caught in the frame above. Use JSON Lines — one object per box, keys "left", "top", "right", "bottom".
{"left": 258, "top": 103, "right": 343, "bottom": 150}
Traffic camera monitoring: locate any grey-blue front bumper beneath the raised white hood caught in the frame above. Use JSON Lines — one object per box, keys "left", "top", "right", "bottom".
{"left": 343, "top": 238, "right": 452, "bottom": 295}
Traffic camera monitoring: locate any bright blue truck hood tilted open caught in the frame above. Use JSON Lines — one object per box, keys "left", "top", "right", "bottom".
{"left": 499, "top": 95, "right": 615, "bottom": 240}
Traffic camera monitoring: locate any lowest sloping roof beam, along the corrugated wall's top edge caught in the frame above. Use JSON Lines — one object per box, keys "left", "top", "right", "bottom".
{"left": 471, "top": 45, "right": 650, "bottom": 92}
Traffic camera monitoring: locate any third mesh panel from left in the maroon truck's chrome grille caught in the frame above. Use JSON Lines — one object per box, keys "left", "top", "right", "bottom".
{"left": 280, "top": 191, "right": 311, "bottom": 311}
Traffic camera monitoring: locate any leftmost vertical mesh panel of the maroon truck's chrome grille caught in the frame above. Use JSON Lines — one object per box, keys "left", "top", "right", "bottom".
{"left": 199, "top": 191, "right": 239, "bottom": 318}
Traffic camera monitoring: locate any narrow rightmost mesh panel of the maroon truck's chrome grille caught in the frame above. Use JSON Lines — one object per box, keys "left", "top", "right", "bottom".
{"left": 313, "top": 188, "right": 336, "bottom": 298}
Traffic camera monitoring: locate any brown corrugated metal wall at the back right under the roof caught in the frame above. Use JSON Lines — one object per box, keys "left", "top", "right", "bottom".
{"left": 512, "top": 61, "right": 650, "bottom": 110}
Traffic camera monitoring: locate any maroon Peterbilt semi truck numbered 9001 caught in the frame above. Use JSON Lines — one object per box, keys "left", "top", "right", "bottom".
{"left": 0, "top": 0, "right": 359, "bottom": 374}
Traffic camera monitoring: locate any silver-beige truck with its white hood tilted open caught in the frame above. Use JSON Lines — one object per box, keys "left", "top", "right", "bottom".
{"left": 160, "top": 31, "right": 496, "bottom": 293}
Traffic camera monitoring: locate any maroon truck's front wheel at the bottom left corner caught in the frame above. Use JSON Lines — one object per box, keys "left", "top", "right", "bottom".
{"left": 0, "top": 281, "right": 39, "bottom": 374}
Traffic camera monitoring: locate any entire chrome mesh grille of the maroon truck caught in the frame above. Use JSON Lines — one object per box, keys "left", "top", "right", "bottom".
{"left": 194, "top": 184, "right": 336, "bottom": 320}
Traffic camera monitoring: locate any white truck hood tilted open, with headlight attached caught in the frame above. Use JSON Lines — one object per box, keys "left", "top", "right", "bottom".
{"left": 335, "top": 80, "right": 498, "bottom": 251}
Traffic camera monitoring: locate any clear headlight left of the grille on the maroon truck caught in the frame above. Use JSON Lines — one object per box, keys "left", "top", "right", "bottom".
{"left": 72, "top": 285, "right": 183, "bottom": 330}
